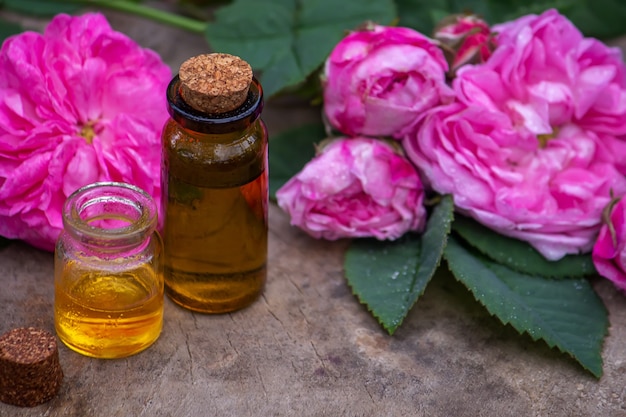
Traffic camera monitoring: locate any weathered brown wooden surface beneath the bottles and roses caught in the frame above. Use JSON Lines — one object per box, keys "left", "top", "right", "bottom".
{"left": 0, "top": 4, "right": 626, "bottom": 417}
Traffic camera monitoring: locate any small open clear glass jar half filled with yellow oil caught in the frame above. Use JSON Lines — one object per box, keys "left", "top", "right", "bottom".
{"left": 54, "top": 182, "right": 164, "bottom": 358}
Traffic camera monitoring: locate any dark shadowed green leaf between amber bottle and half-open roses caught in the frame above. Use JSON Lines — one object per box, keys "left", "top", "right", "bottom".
{"left": 269, "top": 123, "right": 326, "bottom": 199}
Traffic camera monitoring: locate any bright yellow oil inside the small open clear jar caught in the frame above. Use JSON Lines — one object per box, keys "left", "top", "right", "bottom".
{"left": 54, "top": 261, "right": 163, "bottom": 358}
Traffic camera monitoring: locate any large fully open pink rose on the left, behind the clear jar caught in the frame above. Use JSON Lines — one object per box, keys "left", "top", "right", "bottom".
{"left": 0, "top": 14, "right": 171, "bottom": 250}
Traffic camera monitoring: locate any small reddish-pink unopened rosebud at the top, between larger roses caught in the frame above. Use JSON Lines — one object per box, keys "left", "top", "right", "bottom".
{"left": 434, "top": 14, "right": 495, "bottom": 78}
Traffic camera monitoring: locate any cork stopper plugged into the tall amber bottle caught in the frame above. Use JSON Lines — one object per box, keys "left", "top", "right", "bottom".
{"left": 178, "top": 53, "right": 252, "bottom": 113}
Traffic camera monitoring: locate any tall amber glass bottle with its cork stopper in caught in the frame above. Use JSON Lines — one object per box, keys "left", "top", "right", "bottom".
{"left": 161, "top": 54, "right": 268, "bottom": 313}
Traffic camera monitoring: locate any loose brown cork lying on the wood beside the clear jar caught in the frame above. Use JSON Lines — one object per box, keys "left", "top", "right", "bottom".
{"left": 0, "top": 327, "right": 63, "bottom": 407}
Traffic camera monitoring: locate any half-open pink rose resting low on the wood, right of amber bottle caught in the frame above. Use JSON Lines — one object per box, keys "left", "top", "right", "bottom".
{"left": 276, "top": 138, "right": 426, "bottom": 240}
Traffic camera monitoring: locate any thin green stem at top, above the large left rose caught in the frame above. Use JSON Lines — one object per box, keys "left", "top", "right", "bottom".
{"left": 69, "top": 0, "right": 207, "bottom": 33}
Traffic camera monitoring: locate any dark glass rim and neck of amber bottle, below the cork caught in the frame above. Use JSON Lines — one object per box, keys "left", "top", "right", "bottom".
{"left": 167, "top": 75, "right": 263, "bottom": 134}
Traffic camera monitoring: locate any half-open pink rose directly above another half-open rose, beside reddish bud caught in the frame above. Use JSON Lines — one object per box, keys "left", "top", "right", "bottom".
{"left": 322, "top": 26, "right": 452, "bottom": 138}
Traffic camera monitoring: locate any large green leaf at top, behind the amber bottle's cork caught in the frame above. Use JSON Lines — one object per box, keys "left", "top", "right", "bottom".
{"left": 206, "top": 0, "right": 395, "bottom": 97}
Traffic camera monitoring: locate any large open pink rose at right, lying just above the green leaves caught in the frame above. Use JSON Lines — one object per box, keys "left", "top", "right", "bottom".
{"left": 403, "top": 103, "right": 626, "bottom": 260}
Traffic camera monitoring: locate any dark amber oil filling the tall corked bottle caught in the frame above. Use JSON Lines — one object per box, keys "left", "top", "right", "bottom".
{"left": 164, "top": 171, "right": 268, "bottom": 313}
